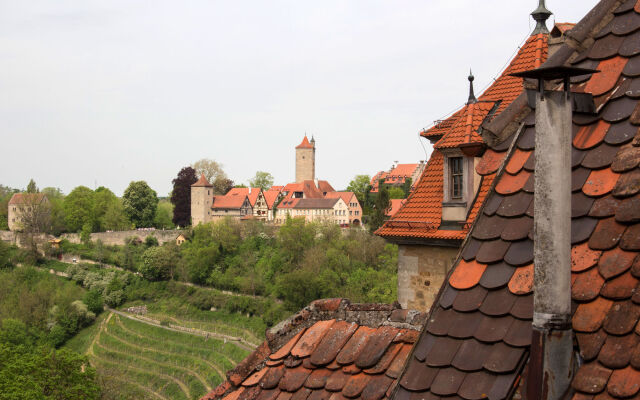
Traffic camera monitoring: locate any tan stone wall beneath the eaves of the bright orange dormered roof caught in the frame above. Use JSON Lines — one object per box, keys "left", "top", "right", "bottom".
{"left": 398, "top": 245, "right": 459, "bottom": 311}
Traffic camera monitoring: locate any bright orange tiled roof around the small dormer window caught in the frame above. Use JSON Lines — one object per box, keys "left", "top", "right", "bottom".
{"left": 376, "top": 34, "right": 548, "bottom": 241}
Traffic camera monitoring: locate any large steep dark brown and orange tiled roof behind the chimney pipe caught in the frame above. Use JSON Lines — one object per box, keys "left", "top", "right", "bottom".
{"left": 396, "top": 0, "right": 640, "bottom": 400}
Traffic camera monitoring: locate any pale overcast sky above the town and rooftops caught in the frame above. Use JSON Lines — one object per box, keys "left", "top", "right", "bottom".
{"left": 0, "top": 0, "right": 597, "bottom": 196}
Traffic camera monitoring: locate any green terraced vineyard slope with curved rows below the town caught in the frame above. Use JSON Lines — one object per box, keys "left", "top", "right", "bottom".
{"left": 86, "top": 313, "right": 249, "bottom": 399}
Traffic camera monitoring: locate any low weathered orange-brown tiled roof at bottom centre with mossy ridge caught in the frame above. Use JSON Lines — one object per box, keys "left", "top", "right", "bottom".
{"left": 202, "top": 299, "right": 425, "bottom": 400}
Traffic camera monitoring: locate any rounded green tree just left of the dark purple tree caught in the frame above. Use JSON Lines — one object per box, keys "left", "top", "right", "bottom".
{"left": 122, "top": 181, "right": 158, "bottom": 228}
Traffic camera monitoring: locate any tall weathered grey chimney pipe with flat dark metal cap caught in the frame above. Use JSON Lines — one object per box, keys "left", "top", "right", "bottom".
{"left": 513, "top": 66, "right": 597, "bottom": 400}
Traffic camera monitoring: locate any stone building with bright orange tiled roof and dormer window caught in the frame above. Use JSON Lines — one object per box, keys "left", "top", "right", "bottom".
{"left": 376, "top": 8, "right": 548, "bottom": 310}
